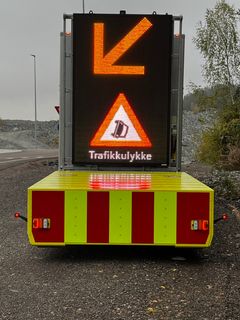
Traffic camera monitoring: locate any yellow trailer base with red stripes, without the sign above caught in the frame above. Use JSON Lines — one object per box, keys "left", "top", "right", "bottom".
{"left": 28, "top": 171, "right": 213, "bottom": 247}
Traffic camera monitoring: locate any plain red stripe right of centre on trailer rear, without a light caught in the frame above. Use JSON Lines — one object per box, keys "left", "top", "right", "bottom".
{"left": 132, "top": 192, "right": 154, "bottom": 243}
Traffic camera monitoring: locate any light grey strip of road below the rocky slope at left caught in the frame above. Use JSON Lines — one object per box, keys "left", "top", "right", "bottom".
{"left": 0, "top": 149, "right": 58, "bottom": 170}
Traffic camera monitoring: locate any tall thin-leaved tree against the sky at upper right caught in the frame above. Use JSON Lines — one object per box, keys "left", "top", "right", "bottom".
{"left": 193, "top": 0, "right": 240, "bottom": 104}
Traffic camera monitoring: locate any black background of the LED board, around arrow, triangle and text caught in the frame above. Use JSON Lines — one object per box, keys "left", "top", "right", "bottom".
{"left": 72, "top": 14, "right": 174, "bottom": 167}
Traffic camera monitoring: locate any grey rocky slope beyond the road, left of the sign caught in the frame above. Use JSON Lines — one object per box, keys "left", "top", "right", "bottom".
{"left": 0, "top": 120, "right": 58, "bottom": 149}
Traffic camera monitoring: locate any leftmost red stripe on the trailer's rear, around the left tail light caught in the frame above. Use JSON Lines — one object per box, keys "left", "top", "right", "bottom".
{"left": 32, "top": 191, "right": 64, "bottom": 243}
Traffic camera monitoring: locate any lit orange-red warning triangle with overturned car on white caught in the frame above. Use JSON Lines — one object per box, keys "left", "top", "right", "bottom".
{"left": 90, "top": 93, "right": 152, "bottom": 148}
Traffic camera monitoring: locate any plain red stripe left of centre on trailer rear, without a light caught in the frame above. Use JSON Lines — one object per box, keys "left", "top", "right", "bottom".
{"left": 87, "top": 192, "right": 109, "bottom": 243}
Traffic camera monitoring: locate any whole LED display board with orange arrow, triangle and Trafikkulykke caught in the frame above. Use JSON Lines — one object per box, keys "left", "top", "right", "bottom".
{"left": 72, "top": 14, "right": 173, "bottom": 166}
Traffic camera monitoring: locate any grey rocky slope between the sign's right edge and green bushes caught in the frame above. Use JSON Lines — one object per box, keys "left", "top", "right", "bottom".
{"left": 182, "top": 110, "right": 216, "bottom": 164}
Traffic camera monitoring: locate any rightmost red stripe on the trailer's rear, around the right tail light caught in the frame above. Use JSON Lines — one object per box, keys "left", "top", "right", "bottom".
{"left": 177, "top": 192, "right": 209, "bottom": 244}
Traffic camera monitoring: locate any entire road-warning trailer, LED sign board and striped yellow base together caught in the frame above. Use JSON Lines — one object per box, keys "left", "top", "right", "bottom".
{"left": 25, "top": 11, "right": 214, "bottom": 247}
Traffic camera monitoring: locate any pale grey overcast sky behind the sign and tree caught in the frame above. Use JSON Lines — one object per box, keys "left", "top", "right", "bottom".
{"left": 0, "top": 0, "right": 240, "bottom": 120}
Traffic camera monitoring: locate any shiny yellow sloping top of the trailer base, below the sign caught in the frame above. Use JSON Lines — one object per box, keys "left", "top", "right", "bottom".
{"left": 30, "top": 171, "right": 212, "bottom": 192}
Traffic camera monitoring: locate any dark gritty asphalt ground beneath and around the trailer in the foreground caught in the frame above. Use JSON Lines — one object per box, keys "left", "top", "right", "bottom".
{"left": 0, "top": 161, "right": 240, "bottom": 320}
